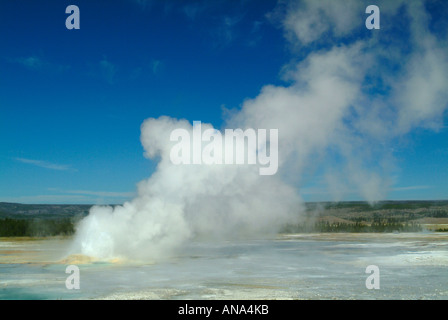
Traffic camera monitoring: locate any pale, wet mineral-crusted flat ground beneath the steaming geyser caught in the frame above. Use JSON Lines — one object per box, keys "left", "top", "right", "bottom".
{"left": 0, "top": 233, "right": 448, "bottom": 300}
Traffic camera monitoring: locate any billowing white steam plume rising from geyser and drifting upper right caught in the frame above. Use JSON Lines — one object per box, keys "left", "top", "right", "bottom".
{"left": 70, "top": 0, "right": 448, "bottom": 259}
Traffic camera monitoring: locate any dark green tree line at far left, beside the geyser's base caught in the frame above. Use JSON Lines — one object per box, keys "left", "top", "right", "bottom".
{"left": 0, "top": 218, "right": 75, "bottom": 237}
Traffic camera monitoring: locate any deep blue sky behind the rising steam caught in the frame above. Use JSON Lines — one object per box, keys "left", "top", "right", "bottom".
{"left": 0, "top": 0, "right": 448, "bottom": 204}
